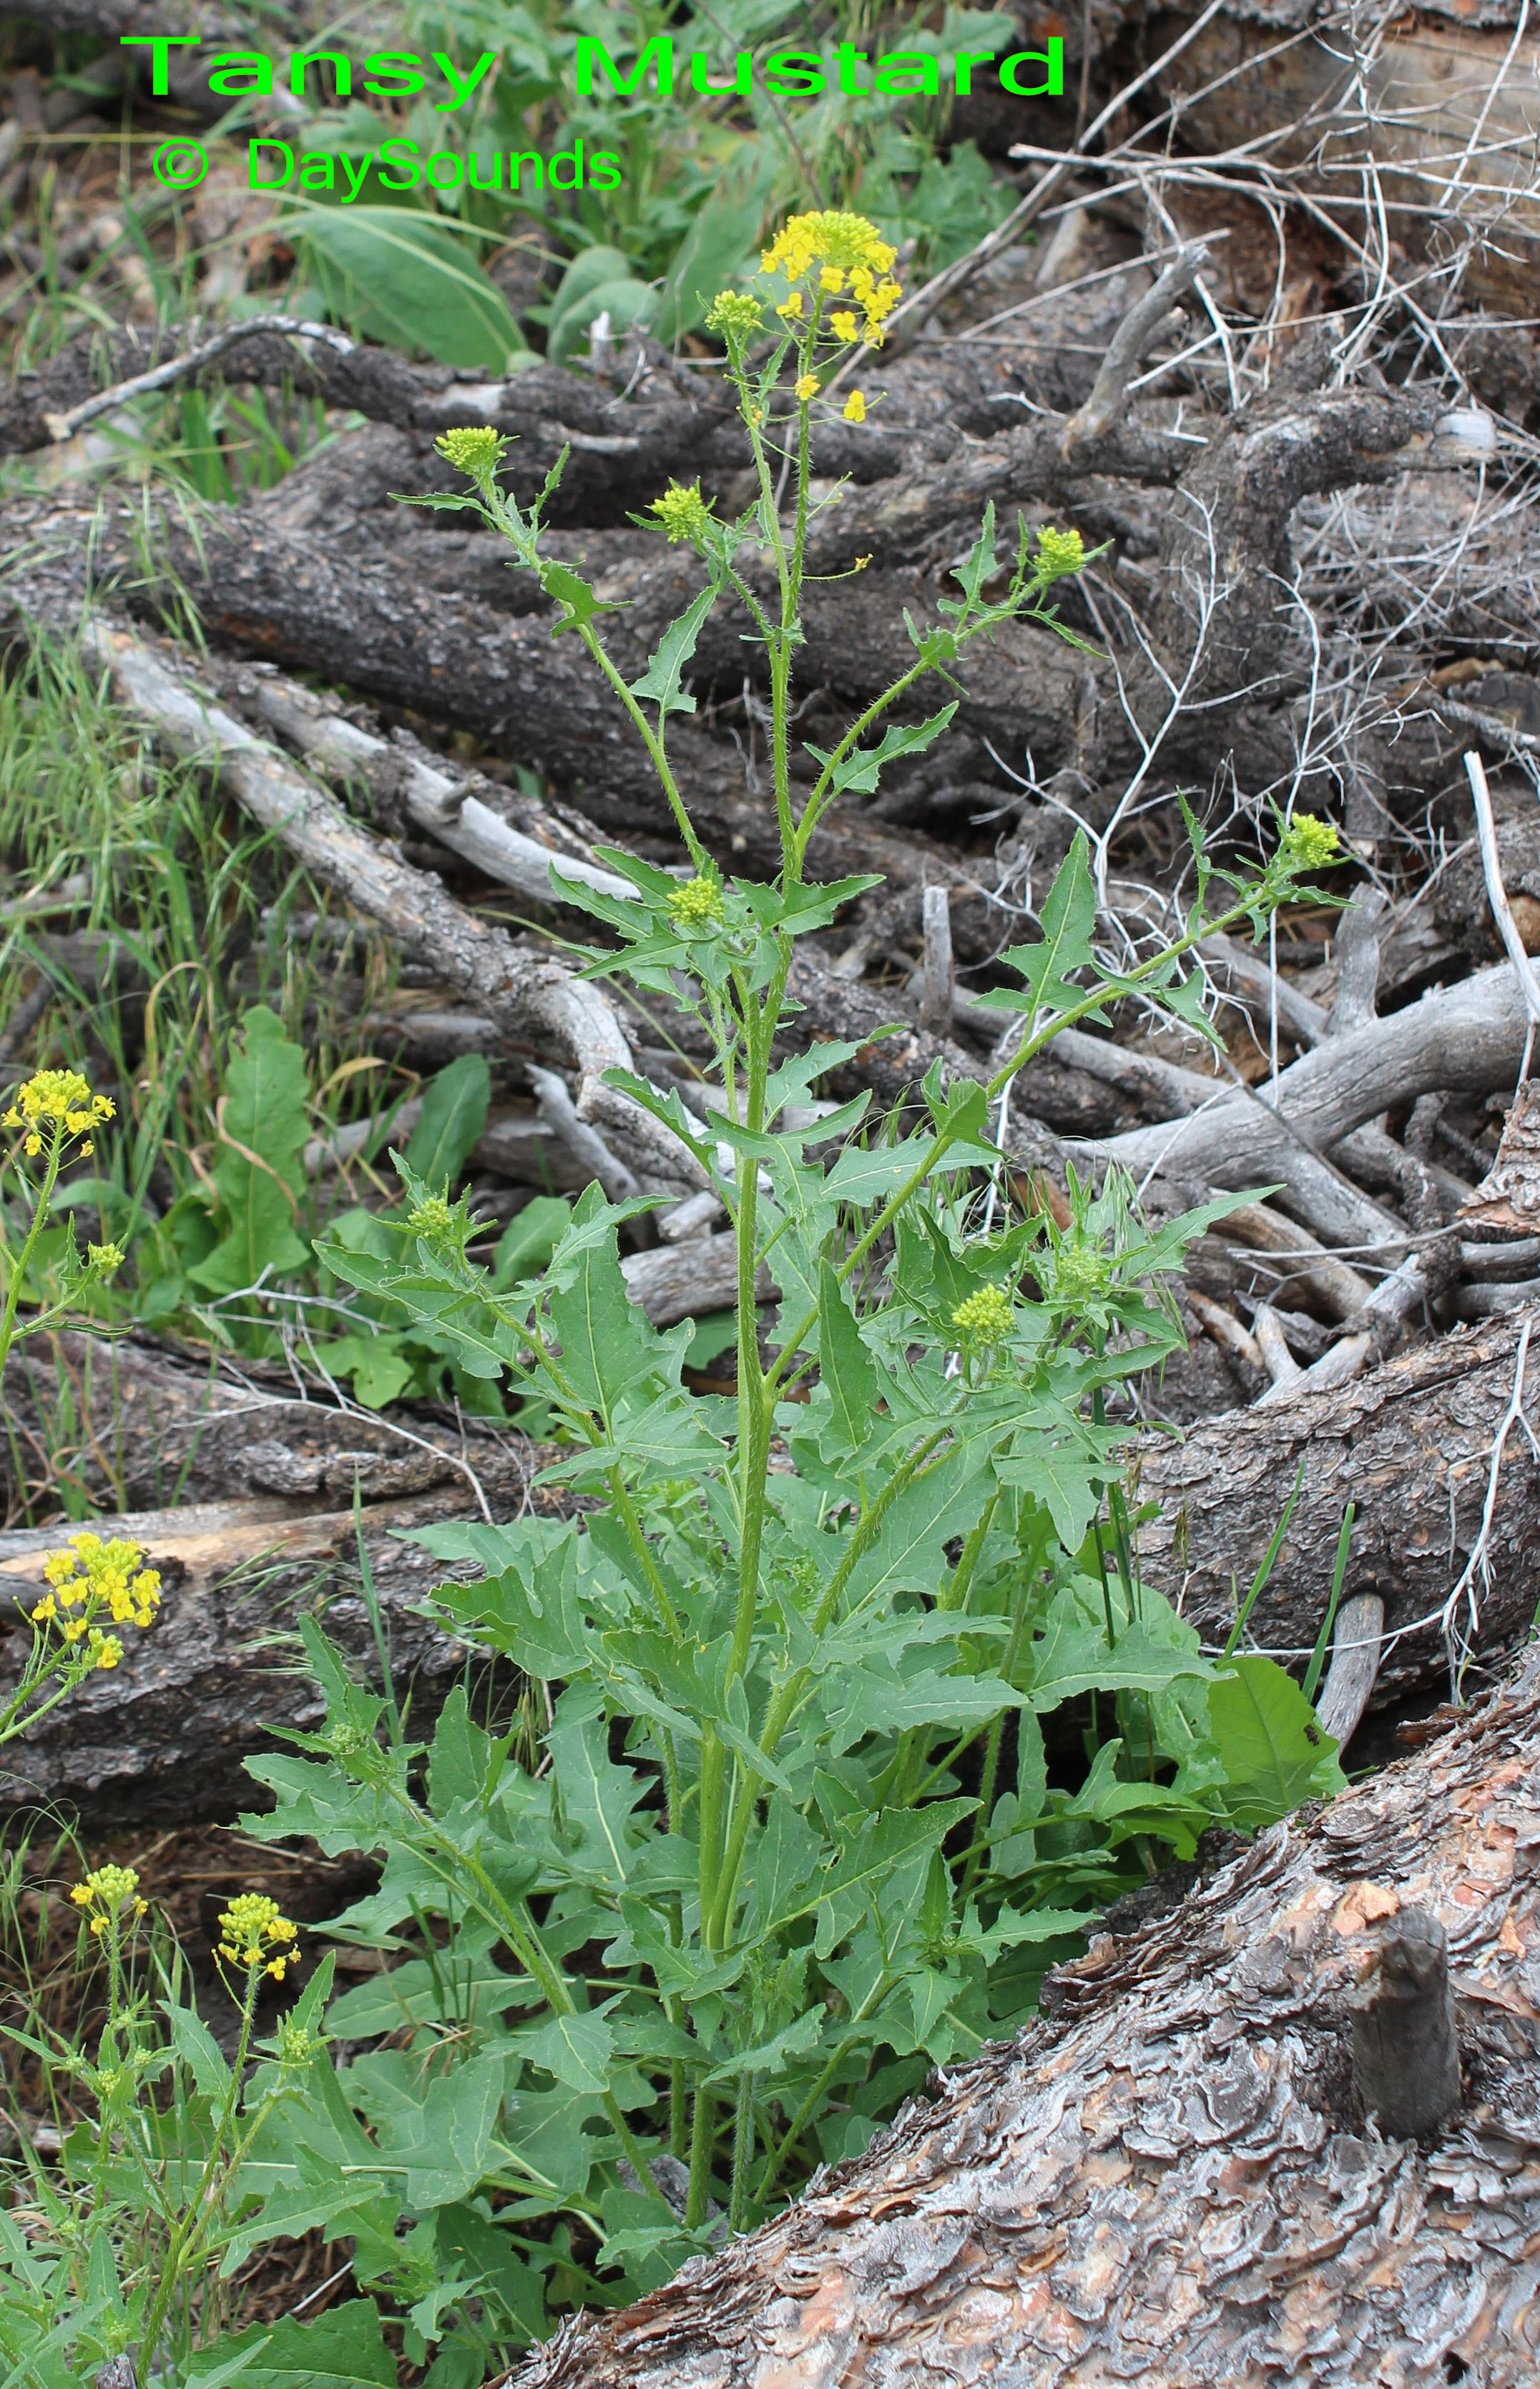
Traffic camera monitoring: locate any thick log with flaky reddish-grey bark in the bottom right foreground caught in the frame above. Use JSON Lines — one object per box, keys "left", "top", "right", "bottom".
{"left": 504, "top": 1656, "right": 1540, "bottom": 2389}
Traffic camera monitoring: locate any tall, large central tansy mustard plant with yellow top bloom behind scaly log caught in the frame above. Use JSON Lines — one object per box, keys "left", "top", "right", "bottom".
{"left": 263, "top": 210, "right": 1337, "bottom": 2327}
